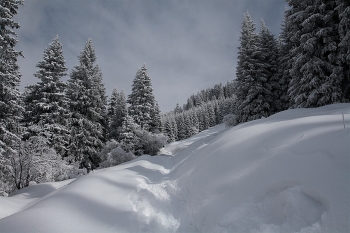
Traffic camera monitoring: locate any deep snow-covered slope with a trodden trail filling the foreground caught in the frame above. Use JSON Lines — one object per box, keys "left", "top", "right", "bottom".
{"left": 0, "top": 104, "right": 350, "bottom": 233}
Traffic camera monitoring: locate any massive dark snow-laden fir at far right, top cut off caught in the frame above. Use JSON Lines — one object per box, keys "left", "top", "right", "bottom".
{"left": 287, "top": 0, "right": 345, "bottom": 108}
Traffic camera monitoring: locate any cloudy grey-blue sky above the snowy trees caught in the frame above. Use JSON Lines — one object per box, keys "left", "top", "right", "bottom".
{"left": 15, "top": 0, "right": 286, "bottom": 112}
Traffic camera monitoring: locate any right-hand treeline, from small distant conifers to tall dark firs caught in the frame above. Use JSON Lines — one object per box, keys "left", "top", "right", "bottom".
{"left": 162, "top": 0, "right": 350, "bottom": 138}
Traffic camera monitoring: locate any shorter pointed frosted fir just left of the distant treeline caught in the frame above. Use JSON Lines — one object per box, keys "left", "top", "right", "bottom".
{"left": 127, "top": 65, "right": 157, "bottom": 131}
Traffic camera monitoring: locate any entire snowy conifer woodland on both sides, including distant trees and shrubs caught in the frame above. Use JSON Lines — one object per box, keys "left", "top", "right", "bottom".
{"left": 0, "top": 0, "right": 350, "bottom": 195}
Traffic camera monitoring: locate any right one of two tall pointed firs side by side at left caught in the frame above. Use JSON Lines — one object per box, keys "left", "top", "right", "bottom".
{"left": 67, "top": 39, "right": 106, "bottom": 161}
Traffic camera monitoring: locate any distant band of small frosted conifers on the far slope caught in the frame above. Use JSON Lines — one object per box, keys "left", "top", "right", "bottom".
{"left": 162, "top": 81, "right": 235, "bottom": 142}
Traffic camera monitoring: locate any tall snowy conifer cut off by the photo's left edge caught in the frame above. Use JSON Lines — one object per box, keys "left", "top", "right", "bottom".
{"left": 0, "top": 0, "right": 23, "bottom": 195}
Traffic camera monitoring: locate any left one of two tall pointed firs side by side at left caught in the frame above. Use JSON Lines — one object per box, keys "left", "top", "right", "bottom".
{"left": 24, "top": 36, "right": 70, "bottom": 157}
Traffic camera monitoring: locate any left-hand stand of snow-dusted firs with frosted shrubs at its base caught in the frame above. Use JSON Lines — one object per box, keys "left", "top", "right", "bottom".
{"left": 0, "top": 0, "right": 166, "bottom": 195}
